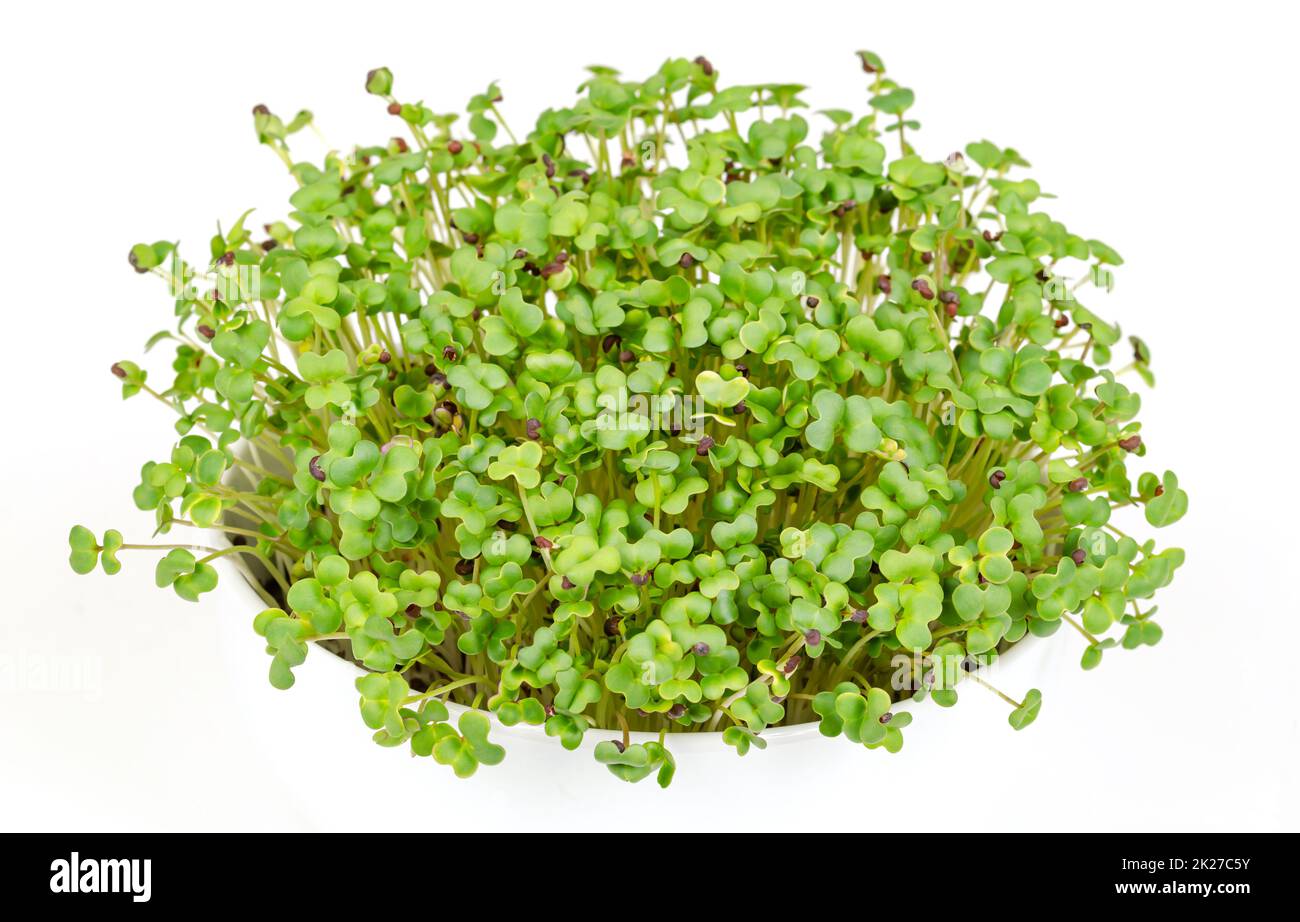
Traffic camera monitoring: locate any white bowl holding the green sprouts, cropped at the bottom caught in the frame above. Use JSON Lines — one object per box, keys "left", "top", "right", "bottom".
{"left": 213, "top": 553, "right": 1078, "bottom": 831}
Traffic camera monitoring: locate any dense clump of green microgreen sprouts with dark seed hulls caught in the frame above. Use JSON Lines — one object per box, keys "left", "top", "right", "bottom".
{"left": 69, "top": 52, "right": 1188, "bottom": 785}
